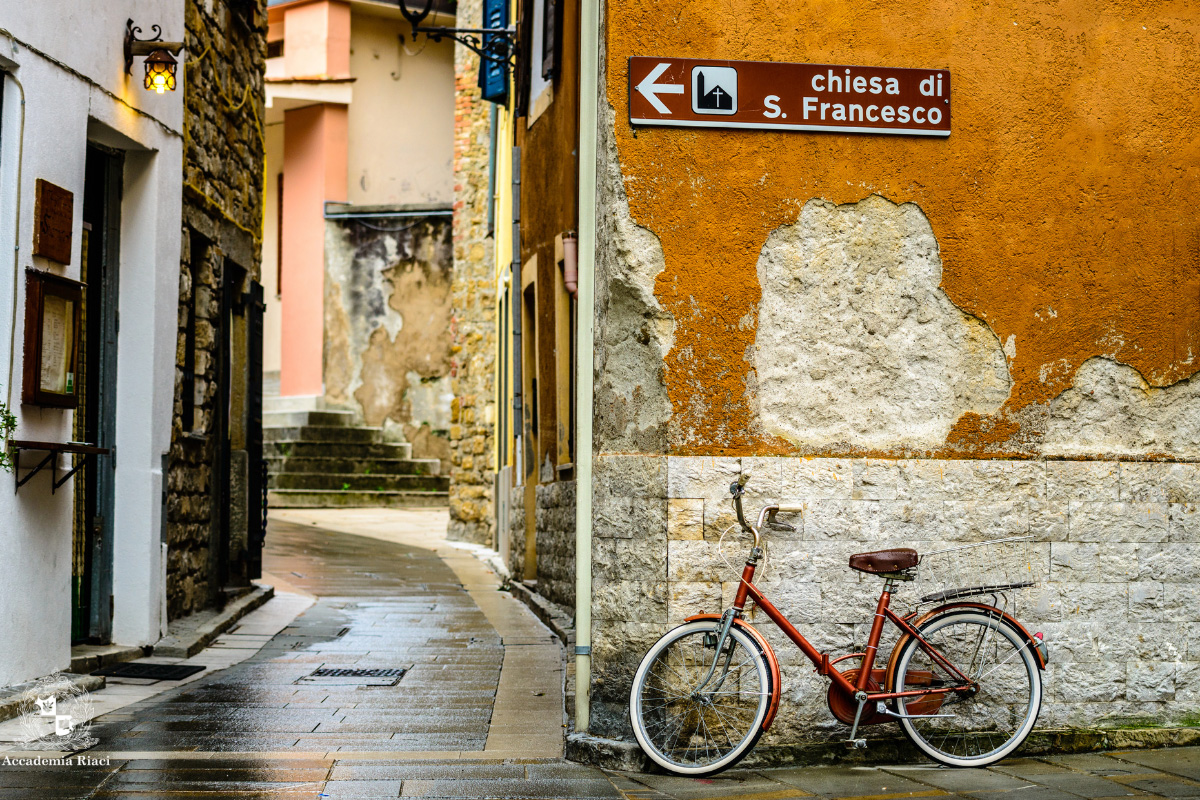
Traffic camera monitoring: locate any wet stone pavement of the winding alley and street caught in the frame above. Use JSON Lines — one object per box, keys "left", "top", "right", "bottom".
{"left": 7, "top": 511, "right": 1200, "bottom": 800}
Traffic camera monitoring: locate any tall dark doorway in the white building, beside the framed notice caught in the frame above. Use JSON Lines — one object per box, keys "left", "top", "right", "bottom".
{"left": 71, "top": 145, "right": 124, "bottom": 643}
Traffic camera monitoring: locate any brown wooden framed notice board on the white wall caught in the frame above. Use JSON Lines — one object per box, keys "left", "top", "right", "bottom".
{"left": 20, "top": 269, "right": 84, "bottom": 408}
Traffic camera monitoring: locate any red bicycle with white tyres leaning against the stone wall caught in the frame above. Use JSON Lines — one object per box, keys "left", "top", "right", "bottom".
{"left": 629, "top": 475, "right": 1046, "bottom": 776}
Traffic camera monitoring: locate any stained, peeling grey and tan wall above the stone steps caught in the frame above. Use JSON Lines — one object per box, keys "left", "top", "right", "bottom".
{"left": 324, "top": 215, "right": 454, "bottom": 459}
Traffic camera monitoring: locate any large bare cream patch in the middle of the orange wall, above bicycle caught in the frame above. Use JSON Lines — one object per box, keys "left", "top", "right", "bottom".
{"left": 755, "top": 196, "right": 1015, "bottom": 450}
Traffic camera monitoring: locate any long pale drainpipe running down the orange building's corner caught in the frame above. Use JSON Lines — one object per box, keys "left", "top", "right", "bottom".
{"left": 575, "top": 0, "right": 600, "bottom": 733}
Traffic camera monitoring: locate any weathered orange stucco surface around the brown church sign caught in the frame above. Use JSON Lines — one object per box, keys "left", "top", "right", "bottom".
{"left": 606, "top": 0, "right": 1200, "bottom": 455}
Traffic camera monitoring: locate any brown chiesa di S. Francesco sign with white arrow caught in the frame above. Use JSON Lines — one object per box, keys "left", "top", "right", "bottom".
{"left": 629, "top": 56, "right": 950, "bottom": 137}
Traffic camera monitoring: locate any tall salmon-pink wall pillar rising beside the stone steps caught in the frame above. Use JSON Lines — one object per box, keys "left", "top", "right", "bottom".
{"left": 280, "top": 103, "right": 348, "bottom": 396}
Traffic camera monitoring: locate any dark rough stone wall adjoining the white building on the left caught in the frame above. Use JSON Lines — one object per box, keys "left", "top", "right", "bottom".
{"left": 166, "top": 0, "right": 266, "bottom": 619}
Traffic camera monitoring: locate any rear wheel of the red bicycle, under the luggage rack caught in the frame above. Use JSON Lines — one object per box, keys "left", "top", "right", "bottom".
{"left": 895, "top": 612, "right": 1042, "bottom": 766}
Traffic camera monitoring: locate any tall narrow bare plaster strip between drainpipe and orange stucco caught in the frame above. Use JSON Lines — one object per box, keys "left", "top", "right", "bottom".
{"left": 594, "top": 97, "right": 674, "bottom": 452}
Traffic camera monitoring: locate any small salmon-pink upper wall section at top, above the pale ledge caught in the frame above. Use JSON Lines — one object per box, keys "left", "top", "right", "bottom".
{"left": 283, "top": 0, "right": 350, "bottom": 78}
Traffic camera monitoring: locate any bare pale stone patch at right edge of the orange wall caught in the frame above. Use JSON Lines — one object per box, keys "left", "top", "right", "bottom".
{"left": 1043, "top": 356, "right": 1200, "bottom": 458}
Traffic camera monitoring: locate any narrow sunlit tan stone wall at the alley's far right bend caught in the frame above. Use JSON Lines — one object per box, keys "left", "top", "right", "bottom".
{"left": 449, "top": 0, "right": 497, "bottom": 546}
